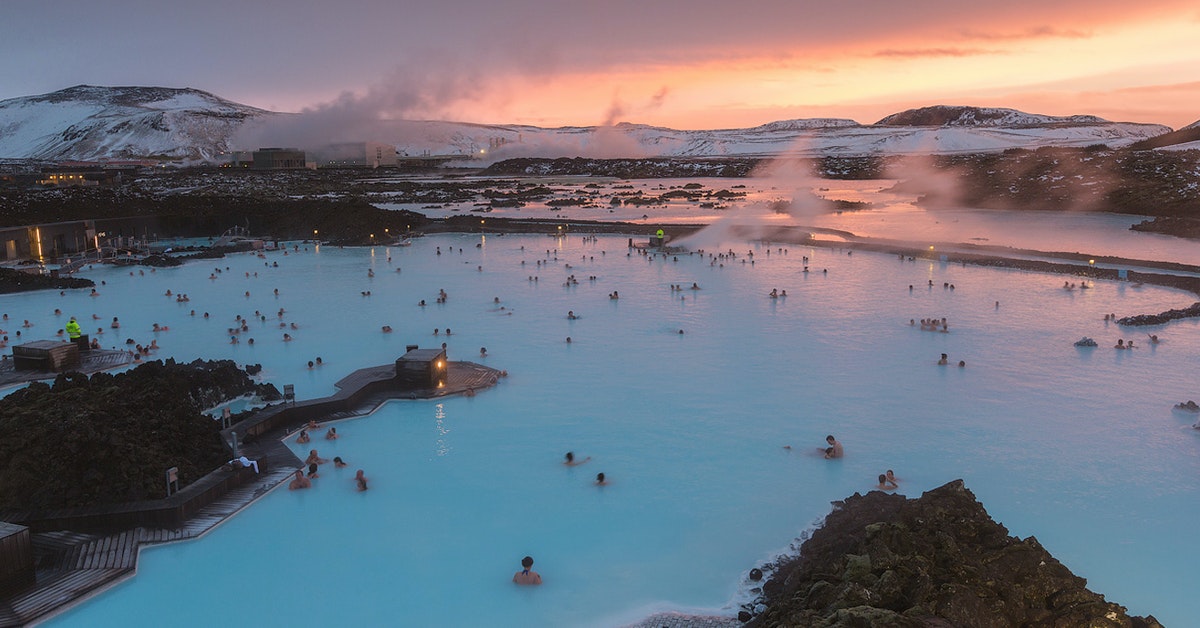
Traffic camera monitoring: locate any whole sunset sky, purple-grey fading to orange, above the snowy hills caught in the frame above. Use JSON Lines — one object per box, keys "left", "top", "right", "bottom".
{"left": 0, "top": 0, "right": 1200, "bottom": 128}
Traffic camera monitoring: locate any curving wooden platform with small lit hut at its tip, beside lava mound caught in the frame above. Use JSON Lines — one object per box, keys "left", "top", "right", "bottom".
{"left": 0, "top": 351, "right": 505, "bottom": 628}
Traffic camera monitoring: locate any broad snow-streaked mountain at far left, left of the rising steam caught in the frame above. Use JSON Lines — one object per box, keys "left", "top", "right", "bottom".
{"left": 0, "top": 85, "right": 275, "bottom": 161}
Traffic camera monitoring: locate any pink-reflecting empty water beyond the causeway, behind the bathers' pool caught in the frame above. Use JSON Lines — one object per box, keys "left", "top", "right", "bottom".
{"left": 379, "top": 173, "right": 1200, "bottom": 265}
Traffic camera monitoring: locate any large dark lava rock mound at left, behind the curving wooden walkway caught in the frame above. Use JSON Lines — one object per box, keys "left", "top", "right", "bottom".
{"left": 0, "top": 360, "right": 267, "bottom": 511}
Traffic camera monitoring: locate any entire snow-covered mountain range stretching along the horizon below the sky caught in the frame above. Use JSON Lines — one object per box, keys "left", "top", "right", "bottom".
{"left": 0, "top": 85, "right": 1171, "bottom": 161}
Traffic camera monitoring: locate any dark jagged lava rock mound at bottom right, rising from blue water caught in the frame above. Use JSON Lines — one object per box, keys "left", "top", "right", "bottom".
{"left": 751, "top": 480, "right": 1160, "bottom": 628}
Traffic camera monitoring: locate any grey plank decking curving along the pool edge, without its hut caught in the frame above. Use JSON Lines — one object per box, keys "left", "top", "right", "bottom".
{"left": 0, "top": 360, "right": 505, "bottom": 628}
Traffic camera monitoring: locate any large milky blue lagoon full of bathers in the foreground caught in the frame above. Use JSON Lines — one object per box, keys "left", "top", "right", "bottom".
{"left": 18, "top": 223, "right": 1200, "bottom": 626}
